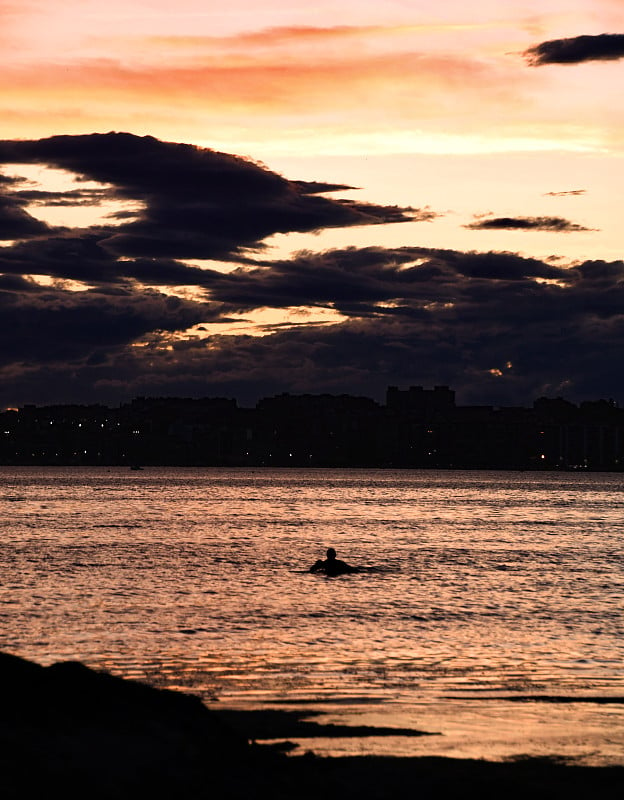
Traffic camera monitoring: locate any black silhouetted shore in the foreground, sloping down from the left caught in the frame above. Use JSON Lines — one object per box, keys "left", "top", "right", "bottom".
{"left": 0, "top": 653, "right": 624, "bottom": 800}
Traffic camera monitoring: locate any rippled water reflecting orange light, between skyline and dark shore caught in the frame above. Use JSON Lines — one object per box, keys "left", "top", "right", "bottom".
{"left": 0, "top": 467, "right": 624, "bottom": 763}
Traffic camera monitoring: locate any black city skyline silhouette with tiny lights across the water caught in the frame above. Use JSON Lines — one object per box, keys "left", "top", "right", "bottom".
{"left": 0, "top": 386, "right": 624, "bottom": 471}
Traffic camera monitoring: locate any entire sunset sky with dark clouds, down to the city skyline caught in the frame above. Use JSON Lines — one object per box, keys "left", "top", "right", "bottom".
{"left": 0, "top": 0, "right": 624, "bottom": 407}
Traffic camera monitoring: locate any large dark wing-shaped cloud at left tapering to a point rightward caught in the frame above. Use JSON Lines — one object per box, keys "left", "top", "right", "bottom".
{"left": 0, "top": 133, "right": 420, "bottom": 259}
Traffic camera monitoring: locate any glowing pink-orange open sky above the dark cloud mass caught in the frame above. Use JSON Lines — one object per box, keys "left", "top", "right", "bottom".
{"left": 0, "top": 0, "right": 624, "bottom": 266}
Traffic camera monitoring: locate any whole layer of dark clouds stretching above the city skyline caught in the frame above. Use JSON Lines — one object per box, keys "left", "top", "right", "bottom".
{"left": 0, "top": 134, "right": 624, "bottom": 405}
